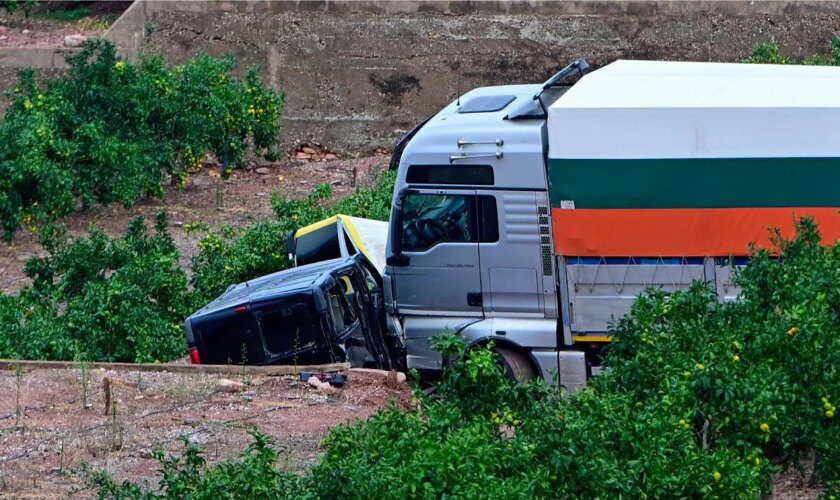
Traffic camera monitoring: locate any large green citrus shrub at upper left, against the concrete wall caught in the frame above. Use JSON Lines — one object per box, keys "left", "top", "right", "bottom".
{"left": 0, "top": 39, "right": 283, "bottom": 239}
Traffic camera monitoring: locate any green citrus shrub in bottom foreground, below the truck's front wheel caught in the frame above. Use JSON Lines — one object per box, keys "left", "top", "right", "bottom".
{"left": 310, "top": 334, "right": 764, "bottom": 498}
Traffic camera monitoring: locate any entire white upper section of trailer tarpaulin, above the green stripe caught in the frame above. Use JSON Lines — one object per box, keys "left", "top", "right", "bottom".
{"left": 548, "top": 61, "right": 840, "bottom": 159}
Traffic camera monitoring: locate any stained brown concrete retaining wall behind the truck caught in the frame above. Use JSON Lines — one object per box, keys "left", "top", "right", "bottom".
{"left": 92, "top": 0, "right": 840, "bottom": 152}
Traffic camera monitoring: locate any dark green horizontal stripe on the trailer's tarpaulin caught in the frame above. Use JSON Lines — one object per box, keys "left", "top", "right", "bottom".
{"left": 548, "top": 158, "right": 840, "bottom": 208}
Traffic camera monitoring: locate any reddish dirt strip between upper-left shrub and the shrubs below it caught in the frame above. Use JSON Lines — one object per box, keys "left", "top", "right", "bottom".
{"left": 0, "top": 155, "right": 388, "bottom": 294}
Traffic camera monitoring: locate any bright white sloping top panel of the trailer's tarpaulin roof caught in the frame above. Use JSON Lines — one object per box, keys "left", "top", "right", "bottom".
{"left": 551, "top": 60, "right": 840, "bottom": 109}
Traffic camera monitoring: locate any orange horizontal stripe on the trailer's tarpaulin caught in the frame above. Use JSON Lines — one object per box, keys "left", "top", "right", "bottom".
{"left": 552, "top": 207, "right": 840, "bottom": 257}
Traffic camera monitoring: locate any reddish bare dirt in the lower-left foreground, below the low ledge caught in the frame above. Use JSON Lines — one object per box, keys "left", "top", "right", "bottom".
{"left": 0, "top": 367, "right": 410, "bottom": 498}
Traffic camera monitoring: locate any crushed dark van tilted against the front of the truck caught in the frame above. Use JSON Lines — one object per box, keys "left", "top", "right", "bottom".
{"left": 184, "top": 254, "right": 405, "bottom": 370}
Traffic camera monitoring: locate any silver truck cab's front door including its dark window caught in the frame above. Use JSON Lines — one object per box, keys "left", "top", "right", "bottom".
{"left": 393, "top": 189, "right": 483, "bottom": 317}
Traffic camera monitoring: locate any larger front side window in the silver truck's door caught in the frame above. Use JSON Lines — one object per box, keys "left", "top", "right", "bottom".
{"left": 402, "top": 193, "right": 477, "bottom": 252}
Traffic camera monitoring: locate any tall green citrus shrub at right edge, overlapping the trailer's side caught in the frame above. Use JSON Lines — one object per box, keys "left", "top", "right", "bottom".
{"left": 610, "top": 219, "right": 840, "bottom": 480}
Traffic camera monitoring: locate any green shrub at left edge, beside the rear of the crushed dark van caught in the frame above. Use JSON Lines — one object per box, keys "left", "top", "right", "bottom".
{"left": 0, "top": 213, "right": 196, "bottom": 362}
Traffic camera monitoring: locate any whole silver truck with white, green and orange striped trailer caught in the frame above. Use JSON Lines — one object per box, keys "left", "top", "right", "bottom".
{"left": 383, "top": 60, "right": 840, "bottom": 391}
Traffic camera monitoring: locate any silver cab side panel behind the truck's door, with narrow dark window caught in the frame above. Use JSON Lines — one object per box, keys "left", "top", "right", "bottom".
{"left": 477, "top": 190, "right": 553, "bottom": 316}
